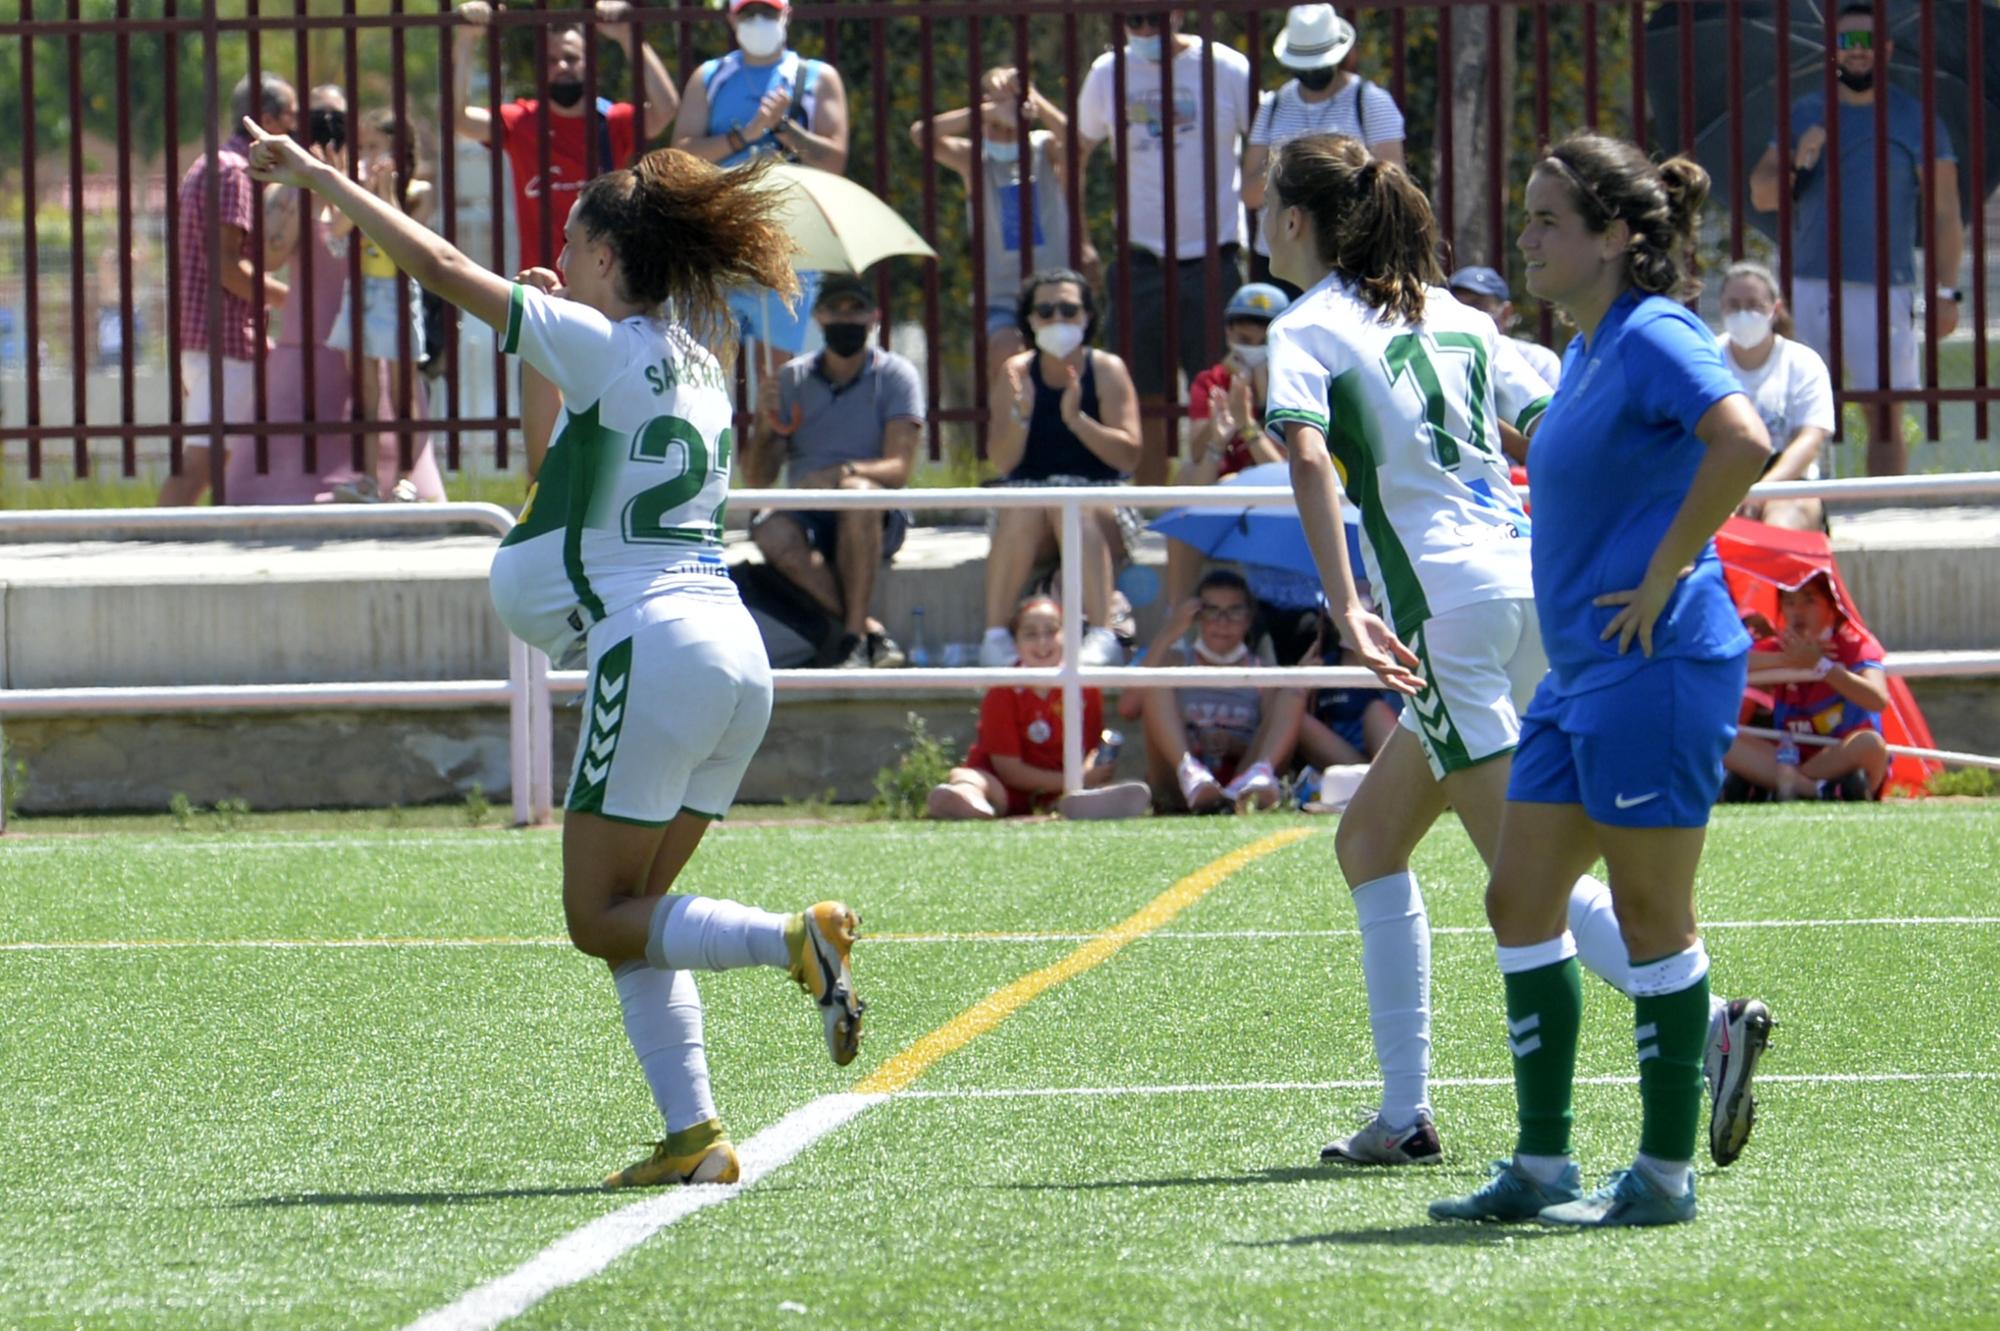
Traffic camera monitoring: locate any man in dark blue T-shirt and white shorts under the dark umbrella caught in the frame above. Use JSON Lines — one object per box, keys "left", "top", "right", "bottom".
{"left": 1750, "top": 0, "right": 1964, "bottom": 476}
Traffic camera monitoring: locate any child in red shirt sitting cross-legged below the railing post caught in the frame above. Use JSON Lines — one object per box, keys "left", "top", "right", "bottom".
{"left": 928, "top": 596, "right": 1152, "bottom": 819}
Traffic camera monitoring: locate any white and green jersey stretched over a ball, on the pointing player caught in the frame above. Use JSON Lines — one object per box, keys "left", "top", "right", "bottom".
{"left": 492, "top": 286, "right": 738, "bottom": 660}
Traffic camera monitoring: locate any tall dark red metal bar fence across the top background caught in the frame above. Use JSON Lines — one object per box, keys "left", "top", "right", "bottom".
{"left": 0, "top": 0, "right": 2000, "bottom": 502}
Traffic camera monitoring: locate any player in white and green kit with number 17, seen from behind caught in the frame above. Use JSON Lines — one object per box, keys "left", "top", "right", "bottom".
{"left": 1264, "top": 134, "right": 1768, "bottom": 1165}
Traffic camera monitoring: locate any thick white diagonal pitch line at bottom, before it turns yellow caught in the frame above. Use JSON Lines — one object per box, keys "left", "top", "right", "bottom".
{"left": 410, "top": 1093, "right": 888, "bottom": 1331}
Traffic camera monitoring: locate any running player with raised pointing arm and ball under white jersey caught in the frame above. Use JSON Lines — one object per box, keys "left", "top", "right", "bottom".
{"left": 238, "top": 128, "right": 862, "bottom": 1187}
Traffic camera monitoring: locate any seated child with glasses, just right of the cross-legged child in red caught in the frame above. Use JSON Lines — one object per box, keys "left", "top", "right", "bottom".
{"left": 1142, "top": 568, "right": 1306, "bottom": 813}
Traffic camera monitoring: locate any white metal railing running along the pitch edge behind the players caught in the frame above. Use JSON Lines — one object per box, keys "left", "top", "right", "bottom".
{"left": 0, "top": 472, "right": 2000, "bottom": 829}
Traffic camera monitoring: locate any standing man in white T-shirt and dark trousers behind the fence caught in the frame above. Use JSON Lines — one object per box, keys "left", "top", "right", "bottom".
{"left": 1076, "top": 10, "right": 1250, "bottom": 486}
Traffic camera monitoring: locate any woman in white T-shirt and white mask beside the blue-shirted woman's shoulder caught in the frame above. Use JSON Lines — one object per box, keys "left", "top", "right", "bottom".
{"left": 1722, "top": 262, "right": 1834, "bottom": 532}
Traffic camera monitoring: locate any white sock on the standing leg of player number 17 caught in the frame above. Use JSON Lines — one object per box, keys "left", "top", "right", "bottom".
{"left": 1354, "top": 873, "right": 1430, "bottom": 1127}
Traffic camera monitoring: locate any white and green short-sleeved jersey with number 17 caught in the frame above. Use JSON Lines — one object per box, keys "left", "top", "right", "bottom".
{"left": 1264, "top": 274, "right": 1550, "bottom": 638}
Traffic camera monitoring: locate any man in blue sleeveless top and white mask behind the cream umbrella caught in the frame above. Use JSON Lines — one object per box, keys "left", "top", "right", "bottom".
{"left": 674, "top": 0, "right": 848, "bottom": 378}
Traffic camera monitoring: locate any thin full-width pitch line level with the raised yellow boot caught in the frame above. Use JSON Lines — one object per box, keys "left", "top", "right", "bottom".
{"left": 15, "top": 915, "right": 2000, "bottom": 951}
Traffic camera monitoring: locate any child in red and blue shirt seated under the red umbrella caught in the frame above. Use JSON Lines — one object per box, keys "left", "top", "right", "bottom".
{"left": 1722, "top": 576, "right": 1888, "bottom": 801}
